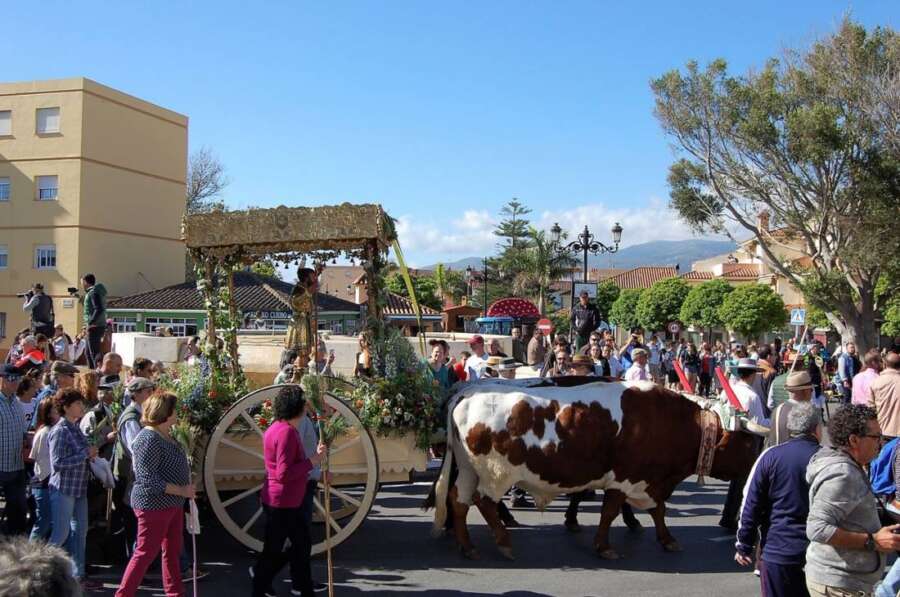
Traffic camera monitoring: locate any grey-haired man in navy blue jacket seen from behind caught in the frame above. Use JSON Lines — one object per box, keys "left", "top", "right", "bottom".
{"left": 734, "top": 402, "right": 821, "bottom": 597}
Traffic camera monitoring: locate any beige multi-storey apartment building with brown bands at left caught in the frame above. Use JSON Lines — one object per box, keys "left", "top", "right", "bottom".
{"left": 0, "top": 78, "right": 188, "bottom": 355}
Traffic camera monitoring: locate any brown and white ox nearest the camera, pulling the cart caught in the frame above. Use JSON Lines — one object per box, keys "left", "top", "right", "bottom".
{"left": 426, "top": 377, "right": 755, "bottom": 559}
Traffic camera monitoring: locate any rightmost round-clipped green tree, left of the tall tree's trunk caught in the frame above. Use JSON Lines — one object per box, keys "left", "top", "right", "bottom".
{"left": 719, "top": 284, "right": 788, "bottom": 339}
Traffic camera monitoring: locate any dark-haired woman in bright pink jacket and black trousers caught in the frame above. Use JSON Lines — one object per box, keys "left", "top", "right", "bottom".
{"left": 250, "top": 385, "right": 325, "bottom": 597}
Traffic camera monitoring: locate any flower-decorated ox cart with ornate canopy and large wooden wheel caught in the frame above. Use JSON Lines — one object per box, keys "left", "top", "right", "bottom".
{"left": 175, "top": 204, "right": 439, "bottom": 554}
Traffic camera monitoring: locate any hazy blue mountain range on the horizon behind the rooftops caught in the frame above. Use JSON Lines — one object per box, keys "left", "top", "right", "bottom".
{"left": 419, "top": 239, "right": 736, "bottom": 273}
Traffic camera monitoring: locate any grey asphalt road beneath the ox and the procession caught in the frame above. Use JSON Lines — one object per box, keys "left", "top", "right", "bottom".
{"left": 86, "top": 480, "right": 759, "bottom": 597}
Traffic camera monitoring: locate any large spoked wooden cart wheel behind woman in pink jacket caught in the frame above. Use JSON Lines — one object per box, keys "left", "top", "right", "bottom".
{"left": 203, "top": 386, "right": 379, "bottom": 555}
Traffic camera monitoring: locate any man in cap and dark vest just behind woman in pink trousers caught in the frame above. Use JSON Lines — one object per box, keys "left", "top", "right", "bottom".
{"left": 113, "top": 377, "right": 156, "bottom": 549}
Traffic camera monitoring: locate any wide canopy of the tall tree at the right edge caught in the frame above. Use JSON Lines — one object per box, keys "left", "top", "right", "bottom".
{"left": 651, "top": 19, "right": 900, "bottom": 349}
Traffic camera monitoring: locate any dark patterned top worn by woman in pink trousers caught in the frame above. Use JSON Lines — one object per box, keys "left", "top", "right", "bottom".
{"left": 131, "top": 427, "right": 191, "bottom": 510}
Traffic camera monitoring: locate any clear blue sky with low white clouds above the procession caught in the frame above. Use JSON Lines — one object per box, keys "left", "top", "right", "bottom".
{"left": 0, "top": 0, "right": 900, "bottom": 265}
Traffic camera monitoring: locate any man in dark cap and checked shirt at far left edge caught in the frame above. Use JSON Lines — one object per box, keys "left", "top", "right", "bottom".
{"left": 0, "top": 365, "right": 28, "bottom": 535}
